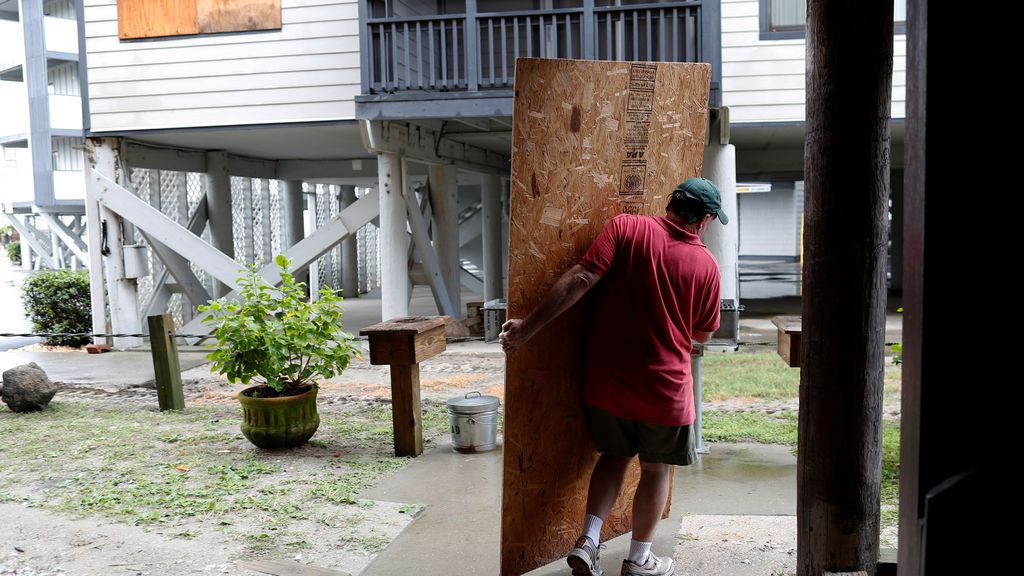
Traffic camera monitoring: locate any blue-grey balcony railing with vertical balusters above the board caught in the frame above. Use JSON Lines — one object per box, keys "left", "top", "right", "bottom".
{"left": 361, "top": 0, "right": 705, "bottom": 94}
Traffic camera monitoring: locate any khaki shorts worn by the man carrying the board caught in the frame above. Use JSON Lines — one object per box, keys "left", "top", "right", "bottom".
{"left": 587, "top": 406, "right": 697, "bottom": 466}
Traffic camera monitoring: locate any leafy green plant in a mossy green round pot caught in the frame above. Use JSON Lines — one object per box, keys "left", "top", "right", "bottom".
{"left": 199, "top": 254, "right": 361, "bottom": 448}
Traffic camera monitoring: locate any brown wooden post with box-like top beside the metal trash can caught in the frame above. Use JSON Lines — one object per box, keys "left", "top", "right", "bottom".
{"left": 359, "top": 316, "right": 446, "bottom": 456}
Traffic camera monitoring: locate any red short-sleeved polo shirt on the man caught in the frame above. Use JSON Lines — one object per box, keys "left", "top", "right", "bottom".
{"left": 580, "top": 214, "right": 721, "bottom": 426}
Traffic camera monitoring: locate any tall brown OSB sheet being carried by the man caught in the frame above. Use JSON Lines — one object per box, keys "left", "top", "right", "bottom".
{"left": 502, "top": 58, "right": 711, "bottom": 576}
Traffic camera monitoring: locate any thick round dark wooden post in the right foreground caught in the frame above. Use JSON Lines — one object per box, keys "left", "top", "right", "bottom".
{"left": 797, "top": 0, "right": 893, "bottom": 576}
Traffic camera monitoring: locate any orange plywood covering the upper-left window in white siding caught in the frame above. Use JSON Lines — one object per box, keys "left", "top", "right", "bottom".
{"left": 118, "top": 0, "right": 281, "bottom": 40}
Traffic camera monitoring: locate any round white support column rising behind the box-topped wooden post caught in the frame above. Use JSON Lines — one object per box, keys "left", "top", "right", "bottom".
{"left": 377, "top": 153, "right": 409, "bottom": 321}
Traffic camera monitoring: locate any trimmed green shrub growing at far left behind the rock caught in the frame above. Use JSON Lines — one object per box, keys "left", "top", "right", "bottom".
{"left": 22, "top": 270, "right": 92, "bottom": 346}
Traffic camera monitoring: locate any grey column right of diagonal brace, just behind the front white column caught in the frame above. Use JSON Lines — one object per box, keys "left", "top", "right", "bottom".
{"left": 429, "top": 164, "right": 464, "bottom": 319}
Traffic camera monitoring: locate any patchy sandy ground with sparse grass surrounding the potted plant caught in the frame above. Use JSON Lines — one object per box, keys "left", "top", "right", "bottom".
{"left": 0, "top": 356, "right": 504, "bottom": 576}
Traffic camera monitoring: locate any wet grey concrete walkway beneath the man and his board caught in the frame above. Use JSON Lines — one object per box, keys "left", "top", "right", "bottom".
{"left": 362, "top": 444, "right": 797, "bottom": 576}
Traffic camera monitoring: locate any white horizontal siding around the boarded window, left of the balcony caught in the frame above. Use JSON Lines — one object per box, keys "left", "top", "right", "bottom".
{"left": 85, "top": 0, "right": 360, "bottom": 132}
